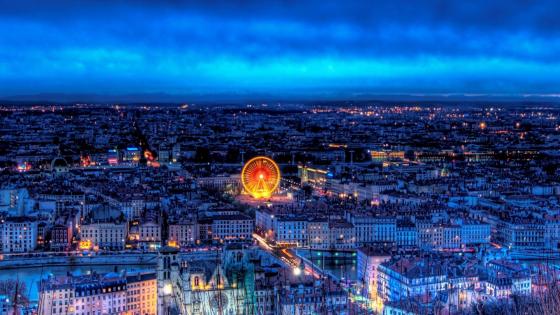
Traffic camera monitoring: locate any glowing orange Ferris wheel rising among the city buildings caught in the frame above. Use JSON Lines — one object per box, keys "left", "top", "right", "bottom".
{"left": 241, "top": 156, "right": 280, "bottom": 198}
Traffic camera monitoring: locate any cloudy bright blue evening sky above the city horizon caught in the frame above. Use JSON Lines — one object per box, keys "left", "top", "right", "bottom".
{"left": 0, "top": 1, "right": 560, "bottom": 101}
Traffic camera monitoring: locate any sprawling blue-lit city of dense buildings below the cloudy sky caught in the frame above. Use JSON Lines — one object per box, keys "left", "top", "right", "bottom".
{"left": 0, "top": 103, "right": 560, "bottom": 315}
